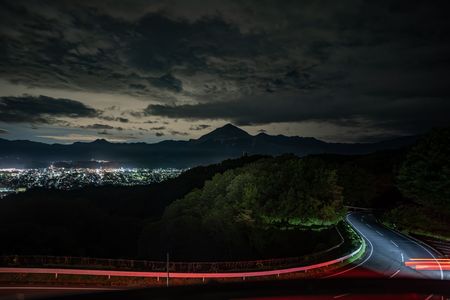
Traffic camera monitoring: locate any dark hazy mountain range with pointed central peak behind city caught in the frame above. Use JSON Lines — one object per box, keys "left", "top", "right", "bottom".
{"left": 0, "top": 124, "right": 418, "bottom": 168}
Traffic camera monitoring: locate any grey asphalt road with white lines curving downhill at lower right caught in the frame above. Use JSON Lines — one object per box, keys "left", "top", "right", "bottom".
{"left": 328, "top": 213, "right": 450, "bottom": 279}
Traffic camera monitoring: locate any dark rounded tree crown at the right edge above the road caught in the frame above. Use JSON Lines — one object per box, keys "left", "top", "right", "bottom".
{"left": 397, "top": 128, "right": 450, "bottom": 211}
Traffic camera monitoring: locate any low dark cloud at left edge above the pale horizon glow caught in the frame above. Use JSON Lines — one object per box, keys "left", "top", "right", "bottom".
{"left": 0, "top": 95, "right": 99, "bottom": 123}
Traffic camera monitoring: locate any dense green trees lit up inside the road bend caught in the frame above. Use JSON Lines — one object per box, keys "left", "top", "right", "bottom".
{"left": 164, "top": 156, "right": 343, "bottom": 225}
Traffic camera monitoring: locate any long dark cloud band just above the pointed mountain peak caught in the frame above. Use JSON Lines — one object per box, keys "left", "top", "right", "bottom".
{"left": 145, "top": 91, "right": 450, "bottom": 131}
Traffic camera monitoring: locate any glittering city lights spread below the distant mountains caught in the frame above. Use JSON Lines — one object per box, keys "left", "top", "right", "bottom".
{"left": 0, "top": 167, "right": 184, "bottom": 198}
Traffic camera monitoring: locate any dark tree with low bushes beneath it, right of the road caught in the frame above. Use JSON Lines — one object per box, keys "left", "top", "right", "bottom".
{"left": 384, "top": 128, "right": 450, "bottom": 240}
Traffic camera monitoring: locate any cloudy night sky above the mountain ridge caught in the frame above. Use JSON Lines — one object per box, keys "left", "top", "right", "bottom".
{"left": 0, "top": 0, "right": 450, "bottom": 143}
